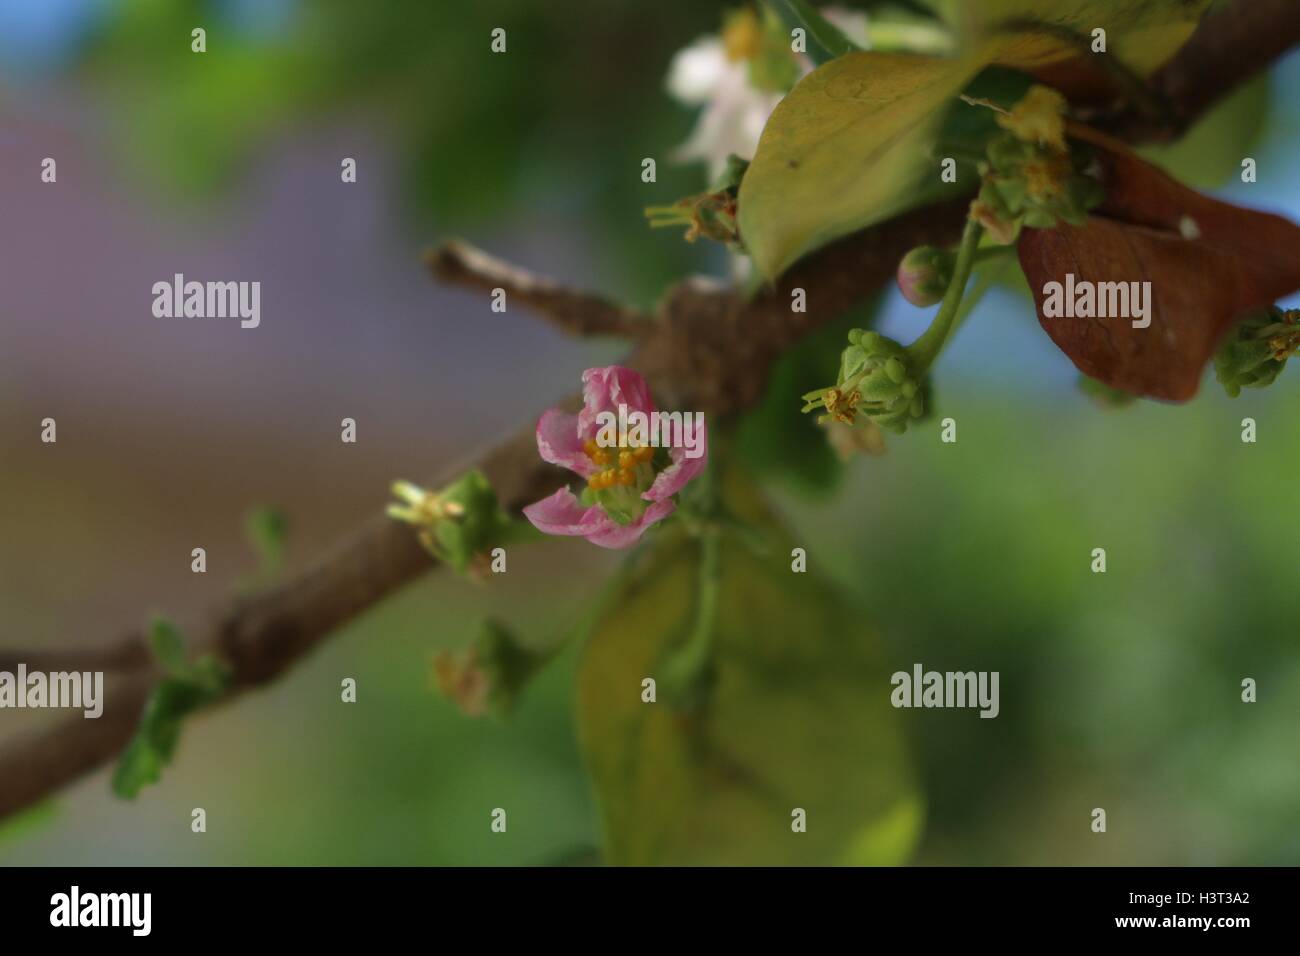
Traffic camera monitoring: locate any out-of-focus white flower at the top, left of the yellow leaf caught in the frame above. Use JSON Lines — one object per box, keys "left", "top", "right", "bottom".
{"left": 668, "top": 36, "right": 781, "bottom": 179}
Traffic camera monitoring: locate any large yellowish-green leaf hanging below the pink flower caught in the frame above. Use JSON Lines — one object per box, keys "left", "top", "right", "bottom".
{"left": 579, "top": 476, "right": 923, "bottom": 865}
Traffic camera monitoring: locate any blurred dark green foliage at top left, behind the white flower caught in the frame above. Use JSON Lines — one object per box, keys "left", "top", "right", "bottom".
{"left": 88, "top": 0, "right": 728, "bottom": 302}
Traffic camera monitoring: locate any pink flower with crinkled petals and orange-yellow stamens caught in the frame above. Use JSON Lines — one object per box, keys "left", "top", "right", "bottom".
{"left": 524, "top": 365, "right": 709, "bottom": 548}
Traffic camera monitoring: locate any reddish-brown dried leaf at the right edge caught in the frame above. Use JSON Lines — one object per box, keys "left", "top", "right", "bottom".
{"left": 1019, "top": 125, "right": 1300, "bottom": 402}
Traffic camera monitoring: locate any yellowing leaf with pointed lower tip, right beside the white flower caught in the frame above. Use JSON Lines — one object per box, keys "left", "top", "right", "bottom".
{"left": 738, "top": 53, "right": 983, "bottom": 277}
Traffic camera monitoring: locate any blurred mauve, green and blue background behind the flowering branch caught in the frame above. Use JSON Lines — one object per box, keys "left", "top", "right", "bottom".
{"left": 0, "top": 0, "right": 1300, "bottom": 865}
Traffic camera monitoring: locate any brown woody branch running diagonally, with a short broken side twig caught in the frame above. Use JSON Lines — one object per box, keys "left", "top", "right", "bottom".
{"left": 0, "top": 0, "right": 1300, "bottom": 817}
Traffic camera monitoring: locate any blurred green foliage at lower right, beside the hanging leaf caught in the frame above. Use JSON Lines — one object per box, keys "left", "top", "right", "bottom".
{"left": 780, "top": 382, "right": 1300, "bottom": 864}
